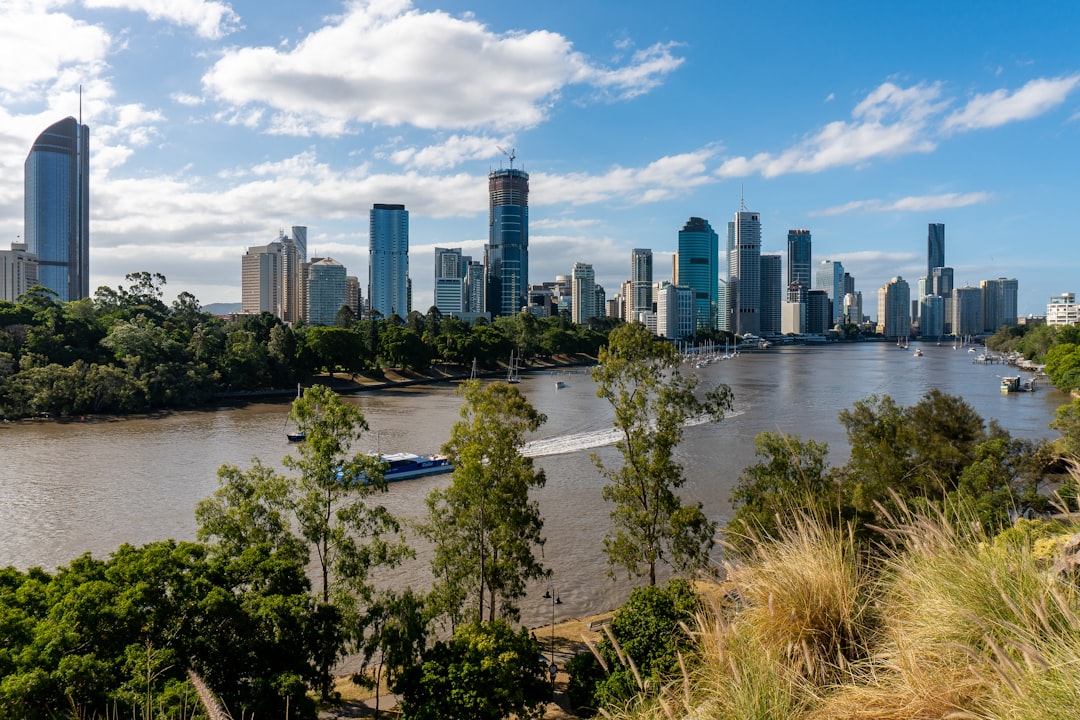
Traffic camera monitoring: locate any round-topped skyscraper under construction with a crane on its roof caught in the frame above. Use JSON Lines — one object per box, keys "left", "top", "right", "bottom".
{"left": 484, "top": 168, "right": 529, "bottom": 317}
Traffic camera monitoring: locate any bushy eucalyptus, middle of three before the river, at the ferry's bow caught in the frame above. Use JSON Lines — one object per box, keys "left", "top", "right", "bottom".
{"left": 422, "top": 380, "right": 546, "bottom": 624}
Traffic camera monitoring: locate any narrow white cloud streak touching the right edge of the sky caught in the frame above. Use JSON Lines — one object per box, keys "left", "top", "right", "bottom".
{"left": 944, "top": 74, "right": 1080, "bottom": 132}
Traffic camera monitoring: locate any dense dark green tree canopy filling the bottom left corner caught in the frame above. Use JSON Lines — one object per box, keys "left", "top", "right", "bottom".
{"left": 0, "top": 541, "right": 315, "bottom": 720}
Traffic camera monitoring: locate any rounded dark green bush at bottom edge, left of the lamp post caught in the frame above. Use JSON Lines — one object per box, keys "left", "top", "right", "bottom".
{"left": 393, "top": 620, "right": 551, "bottom": 720}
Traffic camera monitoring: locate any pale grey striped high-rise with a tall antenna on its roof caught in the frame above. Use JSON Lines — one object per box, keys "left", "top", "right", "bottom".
{"left": 728, "top": 209, "right": 761, "bottom": 335}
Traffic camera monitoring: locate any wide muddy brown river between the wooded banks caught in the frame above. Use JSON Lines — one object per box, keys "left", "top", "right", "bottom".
{"left": 0, "top": 343, "right": 1068, "bottom": 625}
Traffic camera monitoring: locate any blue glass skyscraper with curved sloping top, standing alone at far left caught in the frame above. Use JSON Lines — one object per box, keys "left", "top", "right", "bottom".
{"left": 23, "top": 118, "right": 90, "bottom": 302}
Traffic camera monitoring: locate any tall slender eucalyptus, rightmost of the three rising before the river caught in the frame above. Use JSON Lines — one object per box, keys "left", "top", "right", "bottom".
{"left": 592, "top": 323, "right": 731, "bottom": 585}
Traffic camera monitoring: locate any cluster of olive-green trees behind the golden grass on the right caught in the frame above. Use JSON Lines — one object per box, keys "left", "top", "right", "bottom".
{"left": 726, "top": 390, "right": 1058, "bottom": 551}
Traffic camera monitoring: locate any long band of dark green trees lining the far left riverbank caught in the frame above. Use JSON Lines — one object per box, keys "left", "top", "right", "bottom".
{"left": 0, "top": 272, "right": 606, "bottom": 418}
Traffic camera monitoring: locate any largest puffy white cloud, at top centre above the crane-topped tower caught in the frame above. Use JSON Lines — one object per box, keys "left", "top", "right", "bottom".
{"left": 203, "top": 0, "right": 681, "bottom": 135}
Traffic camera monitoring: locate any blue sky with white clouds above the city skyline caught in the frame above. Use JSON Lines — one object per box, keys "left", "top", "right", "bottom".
{"left": 0, "top": 0, "right": 1080, "bottom": 315}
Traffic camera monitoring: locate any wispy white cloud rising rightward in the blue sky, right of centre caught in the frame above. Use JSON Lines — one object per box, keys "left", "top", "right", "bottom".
{"left": 717, "top": 82, "right": 942, "bottom": 177}
